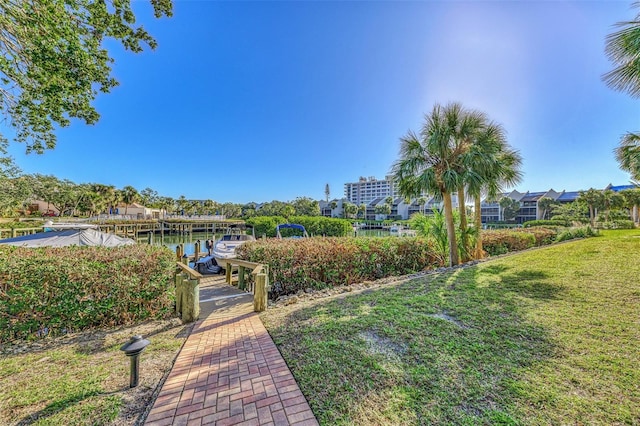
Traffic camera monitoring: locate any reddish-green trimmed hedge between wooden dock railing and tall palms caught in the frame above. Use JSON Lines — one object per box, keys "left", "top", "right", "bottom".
{"left": 238, "top": 237, "right": 441, "bottom": 297}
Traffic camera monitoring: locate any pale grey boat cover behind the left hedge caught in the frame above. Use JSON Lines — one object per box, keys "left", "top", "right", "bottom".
{"left": 0, "top": 229, "right": 136, "bottom": 247}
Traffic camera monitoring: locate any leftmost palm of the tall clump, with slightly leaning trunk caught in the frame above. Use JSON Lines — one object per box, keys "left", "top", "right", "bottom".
{"left": 392, "top": 103, "right": 476, "bottom": 266}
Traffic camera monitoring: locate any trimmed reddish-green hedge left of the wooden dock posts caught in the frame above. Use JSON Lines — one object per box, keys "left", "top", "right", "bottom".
{"left": 0, "top": 245, "right": 175, "bottom": 342}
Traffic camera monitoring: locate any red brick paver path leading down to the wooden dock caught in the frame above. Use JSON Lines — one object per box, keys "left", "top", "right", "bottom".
{"left": 145, "top": 276, "right": 318, "bottom": 426}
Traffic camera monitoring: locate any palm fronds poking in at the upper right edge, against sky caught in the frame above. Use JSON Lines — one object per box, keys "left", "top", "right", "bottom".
{"left": 602, "top": 2, "right": 640, "bottom": 98}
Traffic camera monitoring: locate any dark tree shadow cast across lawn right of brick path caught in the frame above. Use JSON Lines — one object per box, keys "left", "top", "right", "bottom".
{"left": 267, "top": 265, "right": 560, "bottom": 424}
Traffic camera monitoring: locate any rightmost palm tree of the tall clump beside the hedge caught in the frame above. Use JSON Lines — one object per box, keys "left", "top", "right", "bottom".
{"left": 465, "top": 122, "right": 522, "bottom": 258}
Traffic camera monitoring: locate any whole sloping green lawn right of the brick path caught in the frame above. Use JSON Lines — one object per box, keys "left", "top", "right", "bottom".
{"left": 261, "top": 230, "right": 640, "bottom": 425}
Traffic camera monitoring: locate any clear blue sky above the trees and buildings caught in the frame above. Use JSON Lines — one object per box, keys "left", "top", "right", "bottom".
{"left": 10, "top": 0, "right": 640, "bottom": 203}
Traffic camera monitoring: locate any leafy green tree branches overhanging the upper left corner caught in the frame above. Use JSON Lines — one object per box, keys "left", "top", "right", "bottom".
{"left": 0, "top": 0, "right": 172, "bottom": 153}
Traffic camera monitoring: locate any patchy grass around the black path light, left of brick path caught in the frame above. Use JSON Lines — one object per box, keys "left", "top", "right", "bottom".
{"left": 0, "top": 319, "right": 188, "bottom": 426}
